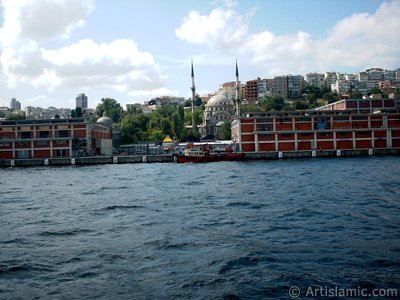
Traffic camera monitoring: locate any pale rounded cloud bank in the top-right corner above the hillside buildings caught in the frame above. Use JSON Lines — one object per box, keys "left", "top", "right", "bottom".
{"left": 316, "top": 1, "right": 400, "bottom": 68}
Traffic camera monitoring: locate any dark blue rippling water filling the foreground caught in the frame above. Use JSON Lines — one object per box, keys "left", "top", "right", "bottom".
{"left": 0, "top": 157, "right": 400, "bottom": 299}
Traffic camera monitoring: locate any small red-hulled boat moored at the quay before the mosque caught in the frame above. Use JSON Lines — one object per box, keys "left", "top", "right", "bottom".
{"left": 176, "top": 144, "right": 244, "bottom": 163}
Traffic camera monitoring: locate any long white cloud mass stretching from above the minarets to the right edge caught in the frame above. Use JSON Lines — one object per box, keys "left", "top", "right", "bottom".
{"left": 175, "top": 0, "right": 400, "bottom": 75}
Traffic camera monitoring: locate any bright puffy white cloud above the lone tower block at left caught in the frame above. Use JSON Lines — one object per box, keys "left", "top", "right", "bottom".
{"left": 42, "top": 39, "right": 167, "bottom": 93}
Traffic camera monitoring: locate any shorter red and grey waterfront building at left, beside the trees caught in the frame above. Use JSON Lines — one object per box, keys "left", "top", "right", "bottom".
{"left": 0, "top": 118, "right": 112, "bottom": 159}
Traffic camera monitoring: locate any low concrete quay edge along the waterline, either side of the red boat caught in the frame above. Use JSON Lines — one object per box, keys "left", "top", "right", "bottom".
{"left": 0, "top": 149, "right": 400, "bottom": 168}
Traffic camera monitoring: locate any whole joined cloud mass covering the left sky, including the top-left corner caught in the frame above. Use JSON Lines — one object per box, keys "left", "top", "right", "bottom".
{"left": 0, "top": 0, "right": 169, "bottom": 103}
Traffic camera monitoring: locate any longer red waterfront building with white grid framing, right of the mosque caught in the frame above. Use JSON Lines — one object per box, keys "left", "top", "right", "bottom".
{"left": 231, "top": 99, "right": 400, "bottom": 153}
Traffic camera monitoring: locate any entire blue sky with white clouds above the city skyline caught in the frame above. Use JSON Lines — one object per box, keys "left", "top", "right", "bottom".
{"left": 0, "top": 0, "right": 400, "bottom": 108}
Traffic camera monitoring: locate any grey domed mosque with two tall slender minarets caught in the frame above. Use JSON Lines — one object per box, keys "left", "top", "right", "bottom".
{"left": 191, "top": 62, "right": 240, "bottom": 139}
